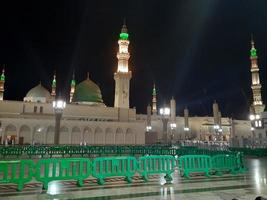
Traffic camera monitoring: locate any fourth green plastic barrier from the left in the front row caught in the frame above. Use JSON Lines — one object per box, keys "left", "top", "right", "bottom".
{"left": 137, "top": 155, "right": 175, "bottom": 181}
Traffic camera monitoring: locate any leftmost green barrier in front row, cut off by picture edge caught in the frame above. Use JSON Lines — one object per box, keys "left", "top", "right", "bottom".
{"left": 0, "top": 160, "right": 34, "bottom": 191}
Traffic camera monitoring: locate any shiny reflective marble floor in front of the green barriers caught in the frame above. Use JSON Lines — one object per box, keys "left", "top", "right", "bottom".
{"left": 0, "top": 158, "right": 267, "bottom": 200}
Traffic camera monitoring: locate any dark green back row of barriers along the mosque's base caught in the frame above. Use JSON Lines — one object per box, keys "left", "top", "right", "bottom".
{"left": 0, "top": 145, "right": 243, "bottom": 158}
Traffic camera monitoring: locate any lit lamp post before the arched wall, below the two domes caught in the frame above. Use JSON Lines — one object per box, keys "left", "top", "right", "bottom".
{"left": 53, "top": 99, "right": 66, "bottom": 144}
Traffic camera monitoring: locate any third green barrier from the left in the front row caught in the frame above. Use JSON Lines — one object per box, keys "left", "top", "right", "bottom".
{"left": 92, "top": 157, "right": 137, "bottom": 185}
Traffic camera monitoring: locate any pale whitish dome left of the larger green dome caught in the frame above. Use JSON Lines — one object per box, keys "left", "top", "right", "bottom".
{"left": 24, "top": 83, "right": 51, "bottom": 102}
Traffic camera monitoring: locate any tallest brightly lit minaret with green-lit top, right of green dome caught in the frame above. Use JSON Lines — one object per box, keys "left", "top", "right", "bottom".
{"left": 114, "top": 22, "right": 132, "bottom": 108}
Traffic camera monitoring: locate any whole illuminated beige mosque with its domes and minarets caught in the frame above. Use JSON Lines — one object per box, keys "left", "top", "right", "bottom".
{"left": 0, "top": 24, "right": 267, "bottom": 146}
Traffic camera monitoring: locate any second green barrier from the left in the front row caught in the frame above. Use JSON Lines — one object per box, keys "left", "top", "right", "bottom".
{"left": 35, "top": 158, "right": 91, "bottom": 190}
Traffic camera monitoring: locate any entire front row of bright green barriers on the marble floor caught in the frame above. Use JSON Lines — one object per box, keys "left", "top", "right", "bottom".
{"left": 0, "top": 153, "right": 247, "bottom": 190}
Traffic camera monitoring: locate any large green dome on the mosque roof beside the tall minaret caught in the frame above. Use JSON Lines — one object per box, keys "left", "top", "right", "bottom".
{"left": 72, "top": 79, "right": 103, "bottom": 103}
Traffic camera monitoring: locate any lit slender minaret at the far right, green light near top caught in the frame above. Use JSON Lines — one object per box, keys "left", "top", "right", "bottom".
{"left": 250, "top": 38, "right": 265, "bottom": 114}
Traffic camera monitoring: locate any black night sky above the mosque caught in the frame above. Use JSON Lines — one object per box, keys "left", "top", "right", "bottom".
{"left": 0, "top": 0, "right": 267, "bottom": 118}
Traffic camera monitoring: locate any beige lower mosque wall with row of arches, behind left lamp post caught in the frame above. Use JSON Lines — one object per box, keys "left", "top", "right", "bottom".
{"left": 0, "top": 118, "right": 145, "bottom": 145}
